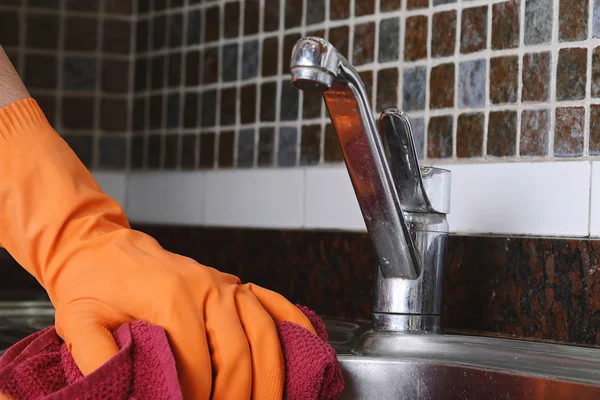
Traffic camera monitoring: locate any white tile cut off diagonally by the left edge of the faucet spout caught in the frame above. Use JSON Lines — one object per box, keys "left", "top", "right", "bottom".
{"left": 304, "top": 166, "right": 367, "bottom": 231}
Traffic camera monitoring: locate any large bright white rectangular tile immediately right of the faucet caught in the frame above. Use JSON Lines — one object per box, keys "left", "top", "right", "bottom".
{"left": 440, "top": 161, "right": 590, "bottom": 236}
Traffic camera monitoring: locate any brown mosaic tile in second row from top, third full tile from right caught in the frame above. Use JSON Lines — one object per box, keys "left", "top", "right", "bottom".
{"left": 490, "top": 56, "right": 519, "bottom": 104}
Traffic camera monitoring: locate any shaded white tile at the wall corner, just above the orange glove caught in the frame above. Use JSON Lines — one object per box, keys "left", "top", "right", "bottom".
{"left": 127, "top": 172, "right": 205, "bottom": 225}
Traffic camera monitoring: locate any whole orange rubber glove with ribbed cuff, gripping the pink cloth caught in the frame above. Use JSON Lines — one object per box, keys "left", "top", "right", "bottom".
{"left": 0, "top": 98, "right": 314, "bottom": 399}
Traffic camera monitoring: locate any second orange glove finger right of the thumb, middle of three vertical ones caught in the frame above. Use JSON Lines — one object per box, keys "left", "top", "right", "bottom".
{"left": 205, "top": 285, "right": 252, "bottom": 400}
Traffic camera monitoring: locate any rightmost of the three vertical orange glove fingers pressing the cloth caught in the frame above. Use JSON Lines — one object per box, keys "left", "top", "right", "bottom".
{"left": 235, "top": 287, "right": 285, "bottom": 400}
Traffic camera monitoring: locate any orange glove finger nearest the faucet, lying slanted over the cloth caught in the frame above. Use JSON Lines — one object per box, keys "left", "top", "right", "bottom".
{"left": 242, "top": 283, "right": 317, "bottom": 335}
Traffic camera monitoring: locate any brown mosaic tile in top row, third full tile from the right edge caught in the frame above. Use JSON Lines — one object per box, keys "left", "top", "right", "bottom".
{"left": 492, "top": 0, "right": 521, "bottom": 50}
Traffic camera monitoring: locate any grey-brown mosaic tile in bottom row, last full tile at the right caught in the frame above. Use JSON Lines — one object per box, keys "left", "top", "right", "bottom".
{"left": 554, "top": 107, "right": 585, "bottom": 157}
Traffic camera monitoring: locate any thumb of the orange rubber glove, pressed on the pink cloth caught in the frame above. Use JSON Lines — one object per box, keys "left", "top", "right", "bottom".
{"left": 60, "top": 317, "right": 119, "bottom": 376}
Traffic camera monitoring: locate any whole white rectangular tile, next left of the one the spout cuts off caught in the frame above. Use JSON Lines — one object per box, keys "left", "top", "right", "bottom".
{"left": 204, "top": 168, "right": 304, "bottom": 228}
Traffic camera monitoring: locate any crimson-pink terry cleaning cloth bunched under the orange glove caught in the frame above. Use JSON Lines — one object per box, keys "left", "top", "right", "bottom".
{"left": 0, "top": 307, "right": 344, "bottom": 400}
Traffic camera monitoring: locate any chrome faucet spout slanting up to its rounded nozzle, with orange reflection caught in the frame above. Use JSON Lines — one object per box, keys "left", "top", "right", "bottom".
{"left": 290, "top": 37, "right": 421, "bottom": 279}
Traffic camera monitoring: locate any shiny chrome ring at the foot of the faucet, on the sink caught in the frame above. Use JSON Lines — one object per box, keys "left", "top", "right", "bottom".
{"left": 373, "top": 313, "right": 442, "bottom": 333}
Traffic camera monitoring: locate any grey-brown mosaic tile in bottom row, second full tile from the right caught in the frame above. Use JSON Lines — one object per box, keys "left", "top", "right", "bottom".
{"left": 519, "top": 110, "right": 550, "bottom": 156}
